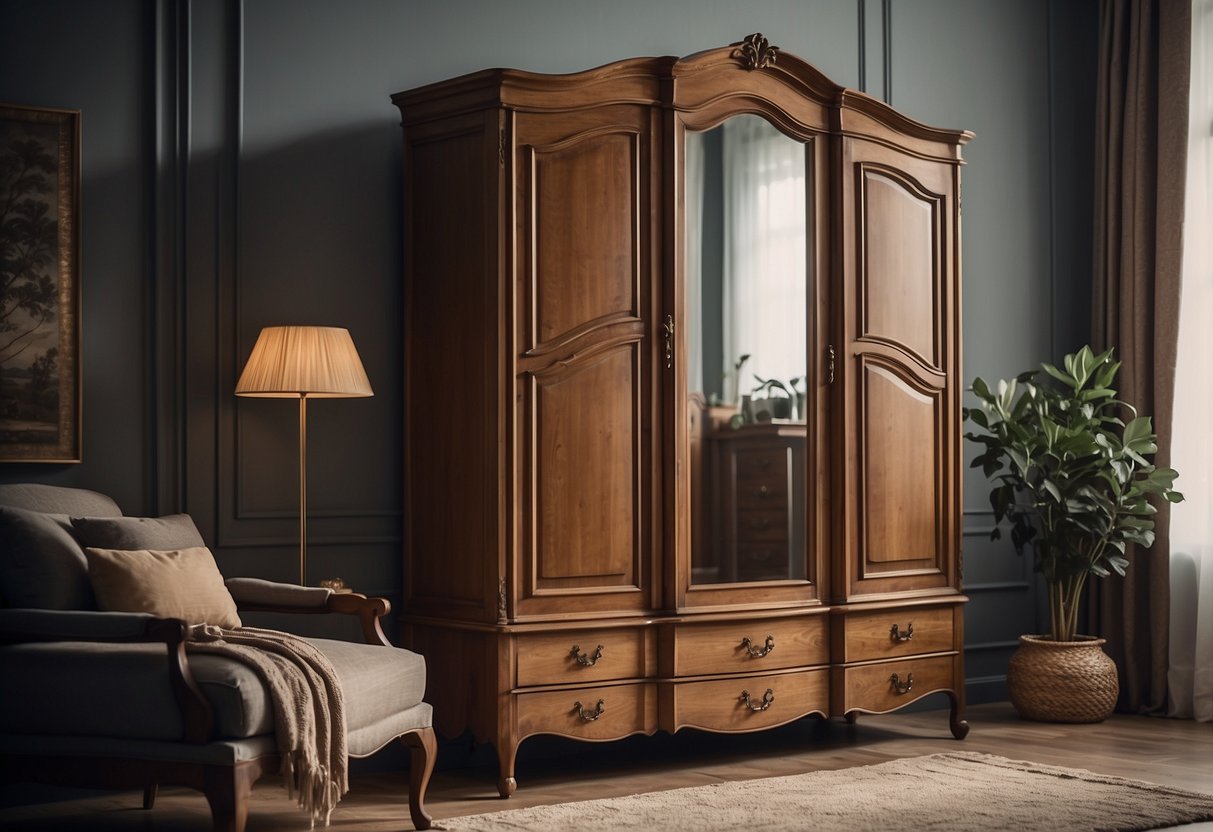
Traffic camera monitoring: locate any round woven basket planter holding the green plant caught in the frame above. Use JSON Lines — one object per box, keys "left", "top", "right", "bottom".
{"left": 1007, "top": 636, "right": 1121, "bottom": 723}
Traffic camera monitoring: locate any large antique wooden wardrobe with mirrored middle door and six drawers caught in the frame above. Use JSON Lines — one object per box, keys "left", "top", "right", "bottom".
{"left": 393, "top": 35, "right": 972, "bottom": 796}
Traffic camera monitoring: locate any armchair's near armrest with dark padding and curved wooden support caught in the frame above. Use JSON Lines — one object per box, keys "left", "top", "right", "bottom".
{"left": 0, "top": 610, "right": 215, "bottom": 745}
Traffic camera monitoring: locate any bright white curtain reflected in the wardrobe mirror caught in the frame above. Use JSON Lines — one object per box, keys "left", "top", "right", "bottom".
{"left": 723, "top": 115, "right": 808, "bottom": 394}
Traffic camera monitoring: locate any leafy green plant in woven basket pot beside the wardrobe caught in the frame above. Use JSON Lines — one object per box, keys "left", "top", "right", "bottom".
{"left": 964, "top": 347, "right": 1184, "bottom": 722}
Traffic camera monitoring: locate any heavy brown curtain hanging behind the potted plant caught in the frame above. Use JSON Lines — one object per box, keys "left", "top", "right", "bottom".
{"left": 1090, "top": 0, "right": 1191, "bottom": 713}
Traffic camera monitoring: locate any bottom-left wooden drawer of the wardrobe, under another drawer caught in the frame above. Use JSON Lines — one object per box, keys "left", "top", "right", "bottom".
{"left": 516, "top": 683, "right": 657, "bottom": 740}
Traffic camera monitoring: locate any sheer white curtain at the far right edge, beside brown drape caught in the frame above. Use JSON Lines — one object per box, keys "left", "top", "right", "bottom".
{"left": 1167, "top": 0, "right": 1213, "bottom": 722}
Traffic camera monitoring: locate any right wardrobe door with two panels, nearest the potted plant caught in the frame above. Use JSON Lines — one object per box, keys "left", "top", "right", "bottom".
{"left": 835, "top": 138, "right": 961, "bottom": 599}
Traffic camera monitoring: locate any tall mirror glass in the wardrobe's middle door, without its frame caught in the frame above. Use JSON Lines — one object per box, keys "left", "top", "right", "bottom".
{"left": 684, "top": 115, "right": 809, "bottom": 583}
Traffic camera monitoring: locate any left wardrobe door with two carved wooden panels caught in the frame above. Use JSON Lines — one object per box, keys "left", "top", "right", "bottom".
{"left": 512, "top": 106, "right": 660, "bottom": 619}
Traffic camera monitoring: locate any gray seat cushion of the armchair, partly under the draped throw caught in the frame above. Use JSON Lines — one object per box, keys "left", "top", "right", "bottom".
{"left": 0, "top": 638, "right": 429, "bottom": 757}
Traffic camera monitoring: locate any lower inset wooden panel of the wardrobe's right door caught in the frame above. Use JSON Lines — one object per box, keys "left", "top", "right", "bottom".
{"left": 861, "top": 363, "right": 940, "bottom": 576}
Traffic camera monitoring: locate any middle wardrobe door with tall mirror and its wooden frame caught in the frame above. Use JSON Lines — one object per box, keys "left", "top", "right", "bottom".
{"left": 671, "top": 114, "right": 828, "bottom": 611}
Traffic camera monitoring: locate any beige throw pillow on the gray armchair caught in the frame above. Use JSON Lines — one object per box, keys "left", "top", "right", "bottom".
{"left": 84, "top": 546, "right": 240, "bottom": 629}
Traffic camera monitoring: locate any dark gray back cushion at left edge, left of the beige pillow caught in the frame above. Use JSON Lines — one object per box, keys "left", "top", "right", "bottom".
{"left": 0, "top": 506, "right": 97, "bottom": 610}
